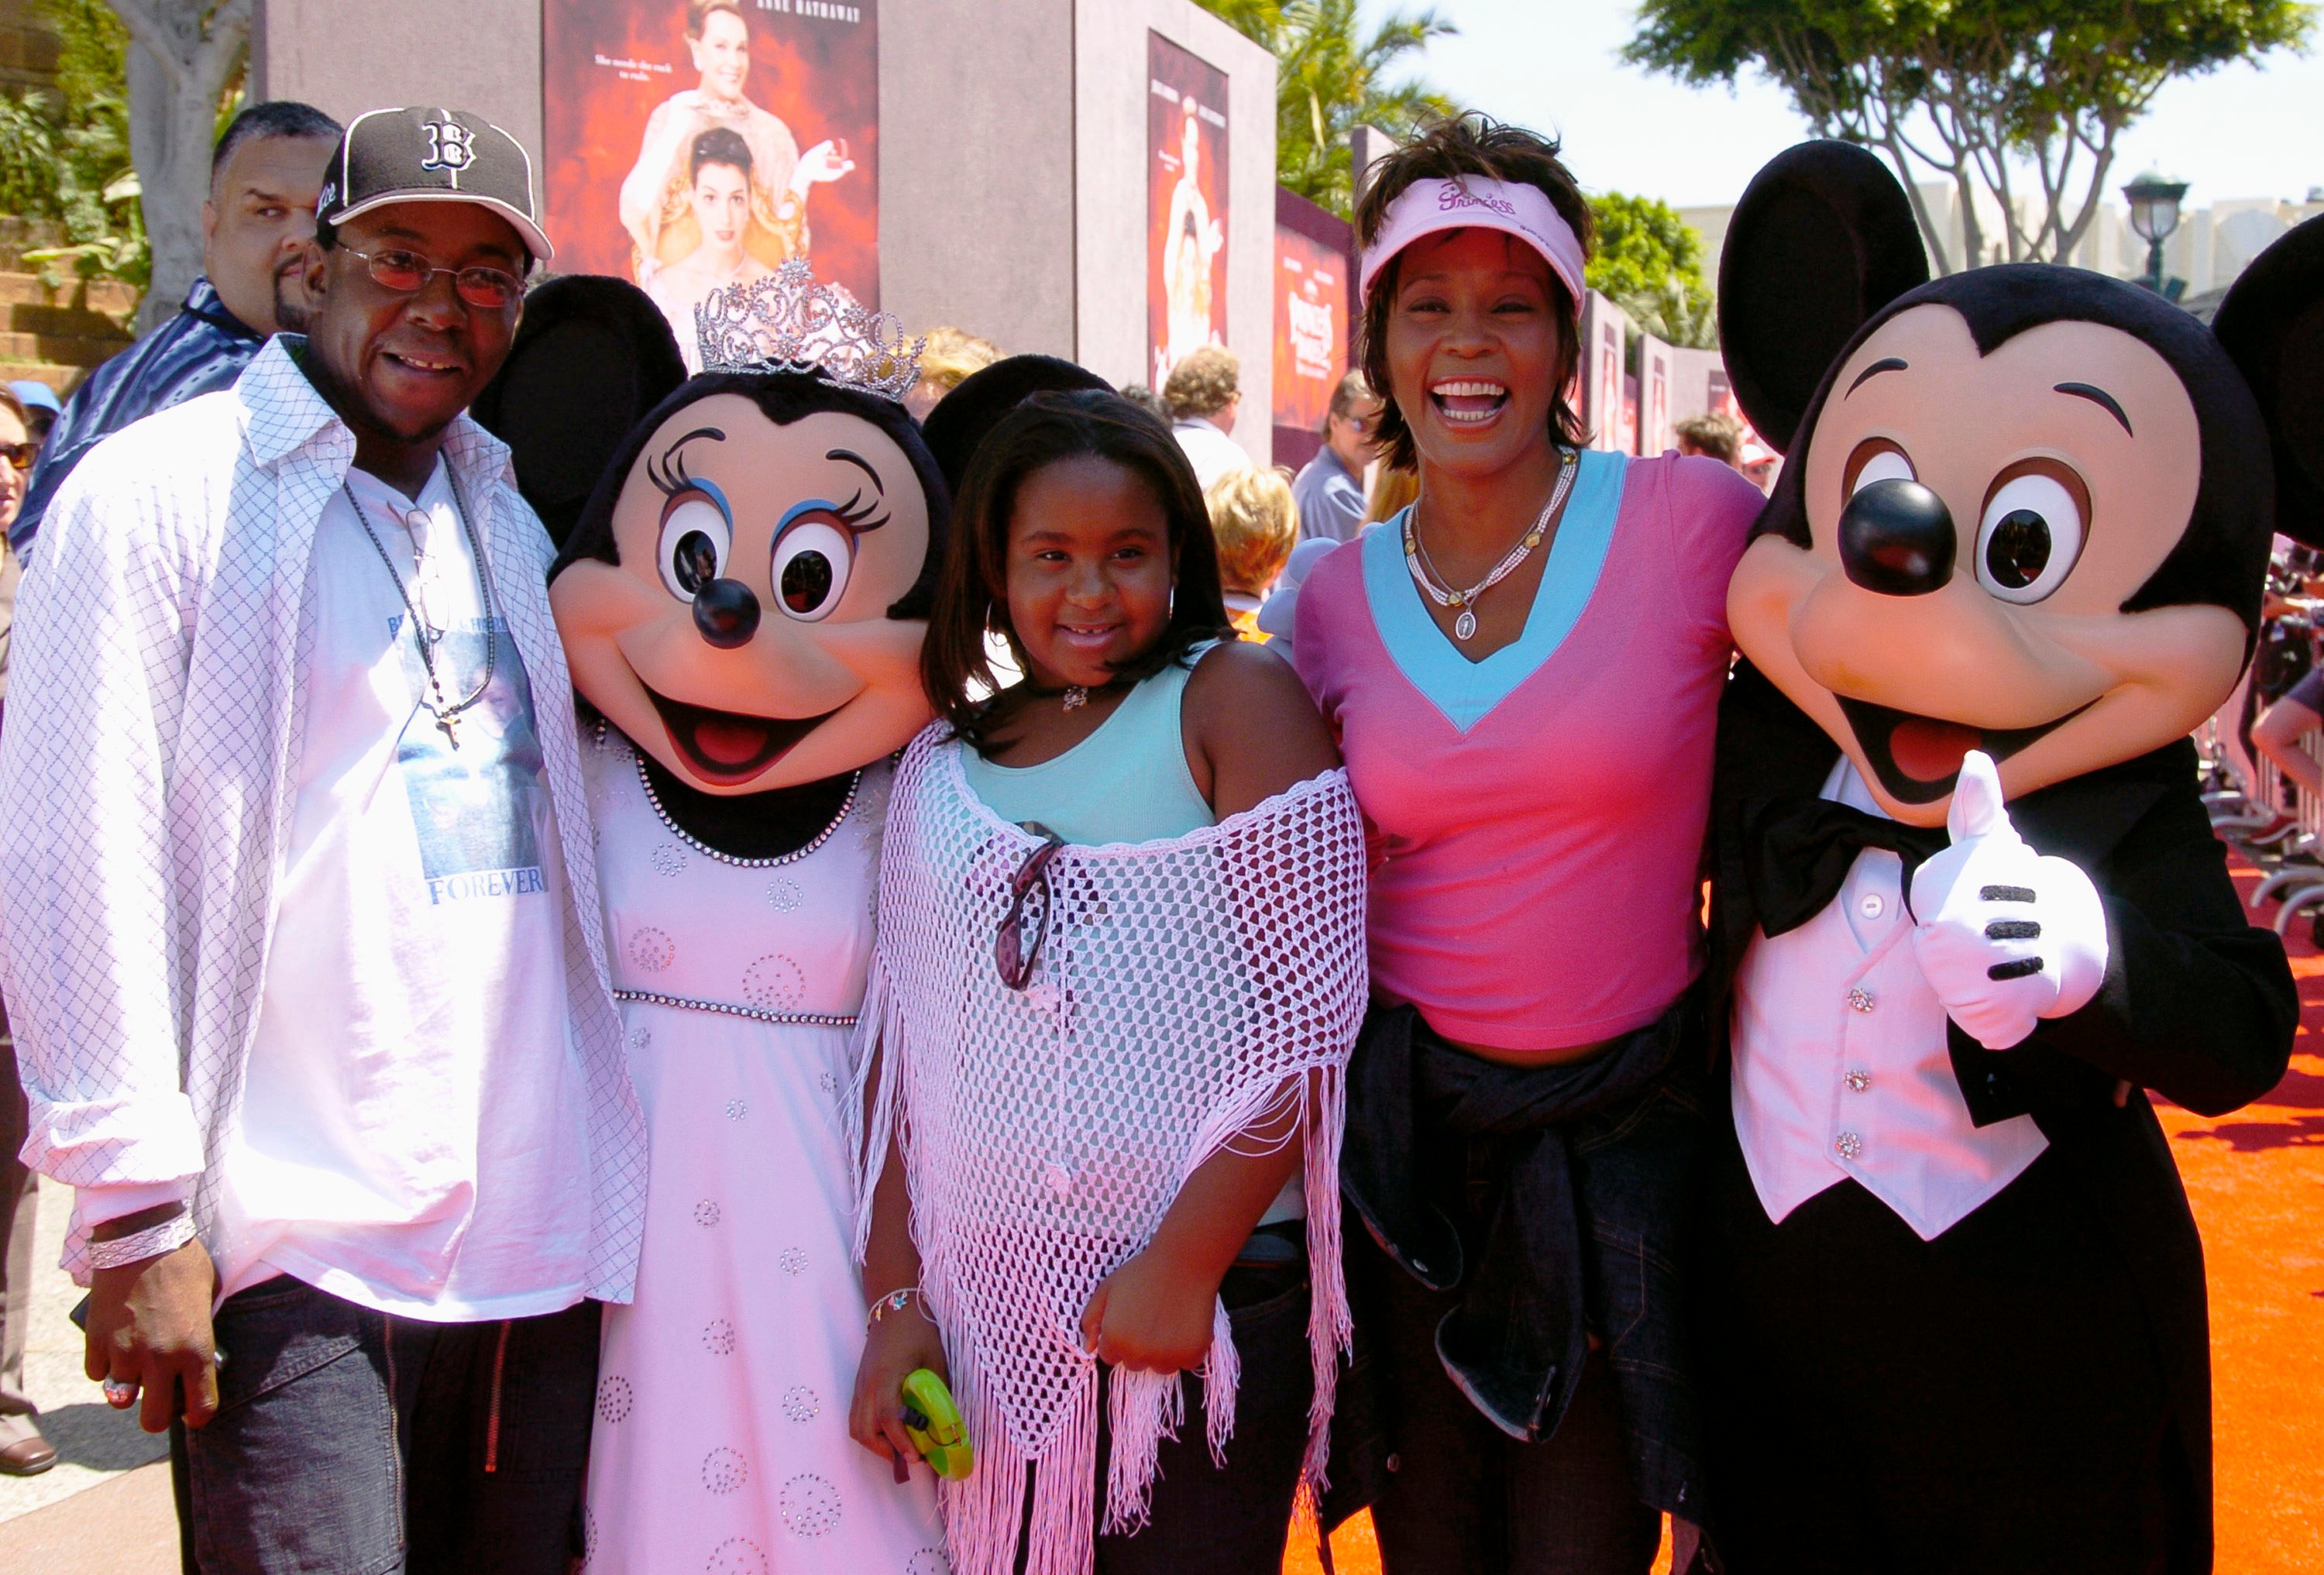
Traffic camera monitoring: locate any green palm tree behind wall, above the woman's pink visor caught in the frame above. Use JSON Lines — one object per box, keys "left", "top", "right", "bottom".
{"left": 1199, "top": 0, "right": 1459, "bottom": 218}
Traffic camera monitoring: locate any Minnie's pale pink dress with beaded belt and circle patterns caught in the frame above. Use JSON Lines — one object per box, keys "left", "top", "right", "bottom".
{"left": 583, "top": 732, "right": 948, "bottom": 1575}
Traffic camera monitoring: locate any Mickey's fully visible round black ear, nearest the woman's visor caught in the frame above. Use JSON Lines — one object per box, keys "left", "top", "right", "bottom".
{"left": 1720, "top": 142, "right": 1929, "bottom": 453}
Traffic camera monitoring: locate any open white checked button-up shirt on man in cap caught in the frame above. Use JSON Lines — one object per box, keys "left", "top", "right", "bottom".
{"left": 0, "top": 339, "right": 646, "bottom": 1301}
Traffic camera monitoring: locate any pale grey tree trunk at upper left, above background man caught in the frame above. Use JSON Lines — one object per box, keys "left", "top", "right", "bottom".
{"left": 109, "top": 0, "right": 251, "bottom": 332}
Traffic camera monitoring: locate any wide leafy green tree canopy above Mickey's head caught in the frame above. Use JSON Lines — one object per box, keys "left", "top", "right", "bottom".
{"left": 1622, "top": 0, "right": 2312, "bottom": 272}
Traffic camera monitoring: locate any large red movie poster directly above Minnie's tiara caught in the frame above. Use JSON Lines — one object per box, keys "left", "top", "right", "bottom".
{"left": 541, "top": 0, "right": 878, "bottom": 370}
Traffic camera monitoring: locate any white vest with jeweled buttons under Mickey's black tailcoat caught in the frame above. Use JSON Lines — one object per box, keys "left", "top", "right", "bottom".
{"left": 1731, "top": 755, "right": 2047, "bottom": 1240}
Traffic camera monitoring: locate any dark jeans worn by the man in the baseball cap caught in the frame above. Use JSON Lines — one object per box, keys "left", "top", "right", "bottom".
{"left": 186, "top": 1275, "right": 597, "bottom": 1575}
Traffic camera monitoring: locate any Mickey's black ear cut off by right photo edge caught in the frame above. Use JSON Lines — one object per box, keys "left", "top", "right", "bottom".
{"left": 2210, "top": 216, "right": 2324, "bottom": 546}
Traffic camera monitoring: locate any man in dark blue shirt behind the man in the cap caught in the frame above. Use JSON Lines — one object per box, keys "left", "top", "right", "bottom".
{"left": 7, "top": 98, "right": 339, "bottom": 555}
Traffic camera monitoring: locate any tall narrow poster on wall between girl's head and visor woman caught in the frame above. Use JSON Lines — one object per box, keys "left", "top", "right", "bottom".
{"left": 1146, "top": 33, "right": 1227, "bottom": 388}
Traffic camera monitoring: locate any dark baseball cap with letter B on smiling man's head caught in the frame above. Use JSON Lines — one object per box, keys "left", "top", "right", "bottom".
{"left": 314, "top": 107, "right": 555, "bottom": 263}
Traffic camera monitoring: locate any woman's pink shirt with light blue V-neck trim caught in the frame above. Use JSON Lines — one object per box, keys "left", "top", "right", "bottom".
{"left": 1292, "top": 451, "right": 1764, "bottom": 1050}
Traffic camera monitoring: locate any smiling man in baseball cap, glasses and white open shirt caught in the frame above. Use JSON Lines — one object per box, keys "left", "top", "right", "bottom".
{"left": 0, "top": 107, "right": 644, "bottom": 1575}
